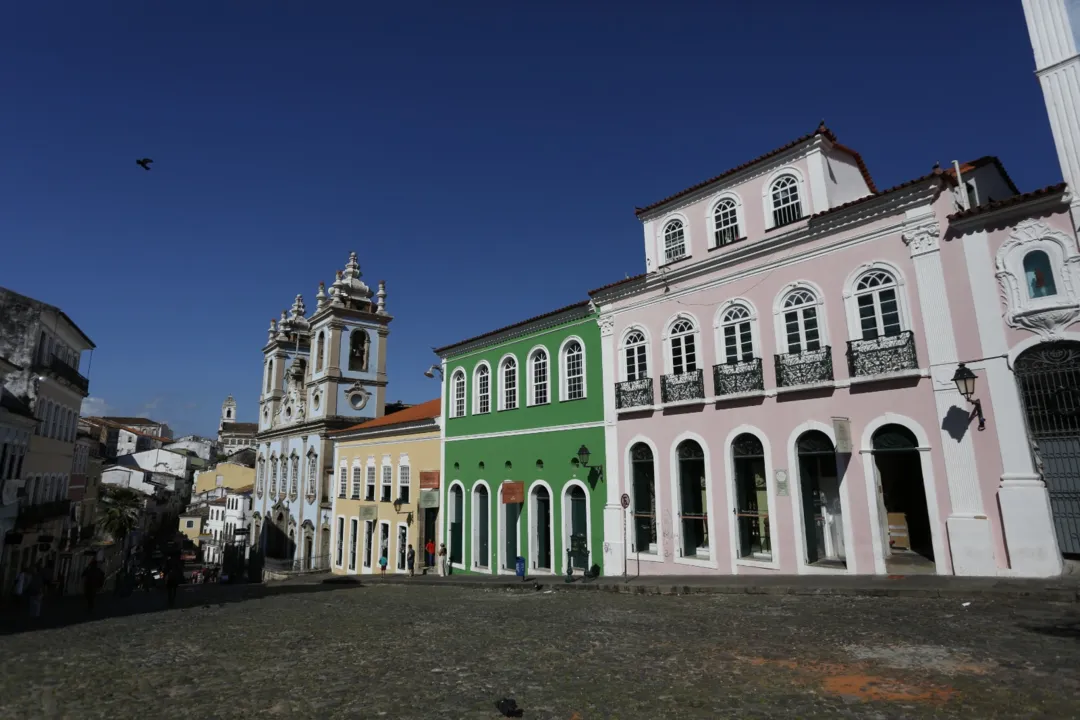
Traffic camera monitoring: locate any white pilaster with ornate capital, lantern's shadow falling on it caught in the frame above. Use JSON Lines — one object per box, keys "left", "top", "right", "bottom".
{"left": 903, "top": 216, "right": 997, "bottom": 575}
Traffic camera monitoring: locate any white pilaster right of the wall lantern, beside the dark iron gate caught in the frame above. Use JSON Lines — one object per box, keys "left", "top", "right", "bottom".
{"left": 962, "top": 230, "right": 1062, "bottom": 578}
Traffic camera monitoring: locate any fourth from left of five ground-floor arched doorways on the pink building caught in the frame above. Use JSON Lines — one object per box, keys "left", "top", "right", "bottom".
{"left": 795, "top": 430, "right": 847, "bottom": 567}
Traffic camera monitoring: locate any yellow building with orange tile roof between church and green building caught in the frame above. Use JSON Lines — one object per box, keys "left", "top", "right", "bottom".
{"left": 330, "top": 399, "right": 442, "bottom": 575}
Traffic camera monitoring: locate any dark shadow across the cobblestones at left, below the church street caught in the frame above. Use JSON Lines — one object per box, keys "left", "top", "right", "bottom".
{"left": 0, "top": 579, "right": 362, "bottom": 636}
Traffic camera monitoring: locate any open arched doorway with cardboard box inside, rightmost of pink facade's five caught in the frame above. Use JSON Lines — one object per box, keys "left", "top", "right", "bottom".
{"left": 872, "top": 424, "right": 936, "bottom": 574}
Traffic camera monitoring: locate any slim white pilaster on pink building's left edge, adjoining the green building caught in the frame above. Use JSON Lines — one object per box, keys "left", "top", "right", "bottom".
{"left": 596, "top": 314, "right": 626, "bottom": 575}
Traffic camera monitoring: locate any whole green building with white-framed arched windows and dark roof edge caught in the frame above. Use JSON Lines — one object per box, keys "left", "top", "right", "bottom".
{"left": 435, "top": 301, "right": 607, "bottom": 576}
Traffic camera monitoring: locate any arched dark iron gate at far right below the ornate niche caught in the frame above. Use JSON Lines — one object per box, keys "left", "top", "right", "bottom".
{"left": 1013, "top": 341, "right": 1080, "bottom": 555}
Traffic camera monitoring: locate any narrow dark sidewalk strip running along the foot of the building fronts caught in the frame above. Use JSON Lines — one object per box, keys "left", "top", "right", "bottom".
{"left": 347, "top": 575, "right": 1080, "bottom": 603}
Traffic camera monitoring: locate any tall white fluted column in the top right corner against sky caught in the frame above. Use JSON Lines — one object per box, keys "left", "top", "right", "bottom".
{"left": 1023, "top": 0, "right": 1080, "bottom": 227}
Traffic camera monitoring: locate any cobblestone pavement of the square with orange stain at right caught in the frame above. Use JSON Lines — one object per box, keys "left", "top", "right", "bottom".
{"left": 0, "top": 580, "right": 1080, "bottom": 720}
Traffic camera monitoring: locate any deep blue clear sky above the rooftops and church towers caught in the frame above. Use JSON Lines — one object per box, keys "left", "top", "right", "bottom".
{"left": 0, "top": 0, "right": 1061, "bottom": 434}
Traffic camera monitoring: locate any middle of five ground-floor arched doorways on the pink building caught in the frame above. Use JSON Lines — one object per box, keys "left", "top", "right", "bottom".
{"left": 731, "top": 433, "right": 772, "bottom": 562}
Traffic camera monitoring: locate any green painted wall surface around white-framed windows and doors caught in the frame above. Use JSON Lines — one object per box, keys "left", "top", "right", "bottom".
{"left": 441, "top": 314, "right": 607, "bottom": 576}
